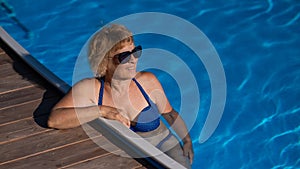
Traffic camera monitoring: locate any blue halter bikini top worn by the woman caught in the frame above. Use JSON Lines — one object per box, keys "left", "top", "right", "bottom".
{"left": 98, "top": 78, "right": 160, "bottom": 132}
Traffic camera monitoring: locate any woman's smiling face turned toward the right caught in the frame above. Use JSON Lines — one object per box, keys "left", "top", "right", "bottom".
{"left": 108, "top": 43, "right": 138, "bottom": 80}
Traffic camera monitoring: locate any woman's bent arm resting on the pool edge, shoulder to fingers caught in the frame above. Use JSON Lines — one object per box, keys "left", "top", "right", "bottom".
{"left": 48, "top": 79, "right": 130, "bottom": 129}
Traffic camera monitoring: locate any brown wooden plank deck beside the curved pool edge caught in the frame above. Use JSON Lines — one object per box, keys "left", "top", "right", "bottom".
{"left": 0, "top": 41, "right": 152, "bottom": 169}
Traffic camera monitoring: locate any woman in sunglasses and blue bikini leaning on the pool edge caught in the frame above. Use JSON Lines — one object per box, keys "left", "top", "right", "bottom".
{"left": 48, "top": 25, "right": 193, "bottom": 168}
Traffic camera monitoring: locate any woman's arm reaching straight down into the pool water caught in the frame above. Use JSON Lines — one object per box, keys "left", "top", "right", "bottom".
{"left": 141, "top": 72, "right": 194, "bottom": 163}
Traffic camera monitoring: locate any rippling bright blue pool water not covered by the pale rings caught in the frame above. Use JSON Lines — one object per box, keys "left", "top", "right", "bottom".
{"left": 0, "top": 0, "right": 300, "bottom": 169}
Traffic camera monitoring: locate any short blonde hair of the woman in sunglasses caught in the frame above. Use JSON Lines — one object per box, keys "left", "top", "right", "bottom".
{"left": 88, "top": 24, "right": 134, "bottom": 77}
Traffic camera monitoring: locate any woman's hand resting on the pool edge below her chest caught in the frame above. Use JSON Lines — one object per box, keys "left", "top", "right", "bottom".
{"left": 100, "top": 105, "right": 130, "bottom": 128}
